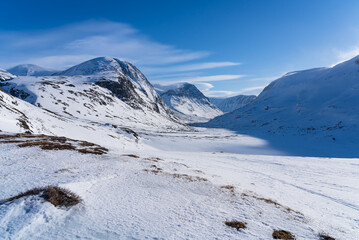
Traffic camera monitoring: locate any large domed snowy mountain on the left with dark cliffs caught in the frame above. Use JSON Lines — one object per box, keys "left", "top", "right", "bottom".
{"left": 2, "top": 57, "right": 180, "bottom": 128}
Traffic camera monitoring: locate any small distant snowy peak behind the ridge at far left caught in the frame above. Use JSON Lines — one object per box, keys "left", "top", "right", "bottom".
{"left": 7, "top": 64, "right": 58, "bottom": 76}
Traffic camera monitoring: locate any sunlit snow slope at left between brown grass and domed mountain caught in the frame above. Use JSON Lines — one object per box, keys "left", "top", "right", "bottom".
{"left": 0, "top": 89, "right": 146, "bottom": 151}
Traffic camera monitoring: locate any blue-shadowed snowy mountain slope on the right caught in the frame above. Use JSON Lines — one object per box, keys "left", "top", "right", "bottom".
{"left": 203, "top": 56, "right": 359, "bottom": 140}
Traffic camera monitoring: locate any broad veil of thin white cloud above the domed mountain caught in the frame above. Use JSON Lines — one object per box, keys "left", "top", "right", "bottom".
{"left": 0, "top": 21, "right": 210, "bottom": 68}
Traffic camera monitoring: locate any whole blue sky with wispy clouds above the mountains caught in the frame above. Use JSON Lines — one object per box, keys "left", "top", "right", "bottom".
{"left": 0, "top": 0, "right": 359, "bottom": 96}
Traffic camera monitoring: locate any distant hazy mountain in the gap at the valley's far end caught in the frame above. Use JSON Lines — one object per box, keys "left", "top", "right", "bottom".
{"left": 209, "top": 95, "right": 256, "bottom": 113}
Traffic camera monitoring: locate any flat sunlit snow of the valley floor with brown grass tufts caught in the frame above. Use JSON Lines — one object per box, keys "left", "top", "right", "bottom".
{"left": 0, "top": 128, "right": 359, "bottom": 240}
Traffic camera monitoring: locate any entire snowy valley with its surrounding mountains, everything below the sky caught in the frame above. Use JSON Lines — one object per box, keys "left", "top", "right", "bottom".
{"left": 0, "top": 57, "right": 359, "bottom": 240}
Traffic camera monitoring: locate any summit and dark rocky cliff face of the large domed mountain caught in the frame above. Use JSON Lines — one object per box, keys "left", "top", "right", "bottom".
{"left": 56, "top": 57, "right": 171, "bottom": 115}
